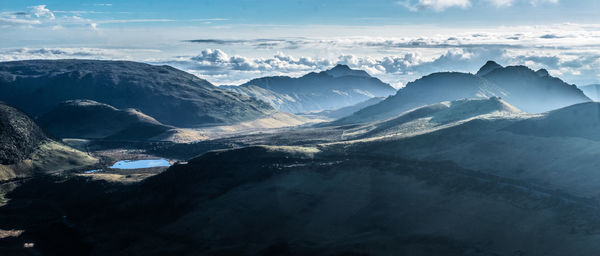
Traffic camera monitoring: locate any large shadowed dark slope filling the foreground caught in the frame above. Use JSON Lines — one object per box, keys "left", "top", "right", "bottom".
{"left": 5, "top": 147, "right": 600, "bottom": 256}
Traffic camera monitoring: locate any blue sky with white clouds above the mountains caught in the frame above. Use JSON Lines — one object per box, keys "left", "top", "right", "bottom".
{"left": 0, "top": 0, "right": 600, "bottom": 87}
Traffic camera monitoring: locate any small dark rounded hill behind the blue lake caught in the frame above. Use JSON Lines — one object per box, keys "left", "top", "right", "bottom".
{"left": 38, "top": 100, "right": 172, "bottom": 140}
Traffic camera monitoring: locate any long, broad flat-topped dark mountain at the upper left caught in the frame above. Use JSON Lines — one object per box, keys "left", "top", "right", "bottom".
{"left": 0, "top": 60, "right": 274, "bottom": 127}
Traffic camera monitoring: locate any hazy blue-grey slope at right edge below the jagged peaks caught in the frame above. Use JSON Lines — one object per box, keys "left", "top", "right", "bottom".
{"left": 506, "top": 102, "right": 600, "bottom": 141}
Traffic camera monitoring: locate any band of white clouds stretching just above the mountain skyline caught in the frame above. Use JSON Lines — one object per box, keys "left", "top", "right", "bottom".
{"left": 0, "top": 22, "right": 600, "bottom": 85}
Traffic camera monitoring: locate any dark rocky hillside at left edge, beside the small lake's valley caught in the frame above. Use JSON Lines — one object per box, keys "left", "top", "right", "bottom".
{"left": 0, "top": 102, "right": 46, "bottom": 165}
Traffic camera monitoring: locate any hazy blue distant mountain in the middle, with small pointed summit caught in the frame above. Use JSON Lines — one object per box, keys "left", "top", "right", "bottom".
{"left": 228, "top": 65, "right": 396, "bottom": 113}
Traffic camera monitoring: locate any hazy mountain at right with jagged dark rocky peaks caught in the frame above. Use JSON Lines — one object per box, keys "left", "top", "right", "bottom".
{"left": 333, "top": 62, "right": 590, "bottom": 124}
